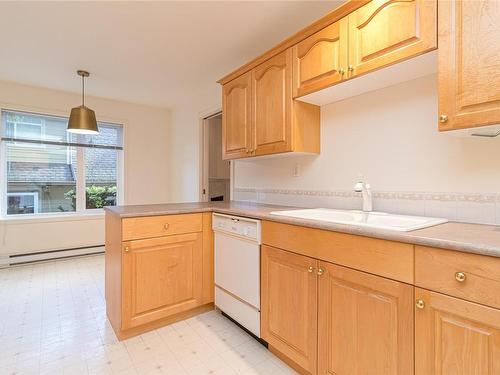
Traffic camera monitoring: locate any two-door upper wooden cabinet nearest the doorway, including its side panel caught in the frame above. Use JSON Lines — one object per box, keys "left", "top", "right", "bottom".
{"left": 222, "top": 51, "right": 320, "bottom": 159}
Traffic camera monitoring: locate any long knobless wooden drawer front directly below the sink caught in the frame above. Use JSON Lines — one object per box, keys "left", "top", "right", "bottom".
{"left": 262, "top": 221, "right": 414, "bottom": 284}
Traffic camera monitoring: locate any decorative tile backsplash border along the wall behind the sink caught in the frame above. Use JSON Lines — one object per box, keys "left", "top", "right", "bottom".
{"left": 233, "top": 187, "right": 500, "bottom": 225}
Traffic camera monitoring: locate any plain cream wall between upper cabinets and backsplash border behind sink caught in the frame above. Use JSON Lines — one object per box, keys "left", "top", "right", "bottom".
{"left": 235, "top": 75, "right": 500, "bottom": 222}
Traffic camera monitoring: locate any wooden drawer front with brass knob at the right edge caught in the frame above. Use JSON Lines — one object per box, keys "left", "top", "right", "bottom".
{"left": 415, "top": 246, "right": 500, "bottom": 308}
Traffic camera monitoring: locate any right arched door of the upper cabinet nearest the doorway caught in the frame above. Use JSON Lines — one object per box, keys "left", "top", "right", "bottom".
{"left": 252, "top": 50, "right": 292, "bottom": 155}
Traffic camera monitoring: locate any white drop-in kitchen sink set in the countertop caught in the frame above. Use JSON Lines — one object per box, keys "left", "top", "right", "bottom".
{"left": 271, "top": 208, "right": 448, "bottom": 232}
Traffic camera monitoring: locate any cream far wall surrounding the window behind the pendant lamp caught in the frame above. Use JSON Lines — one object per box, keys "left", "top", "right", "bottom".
{"left": 0, "top": 82, "right": 170, "bottom": 256}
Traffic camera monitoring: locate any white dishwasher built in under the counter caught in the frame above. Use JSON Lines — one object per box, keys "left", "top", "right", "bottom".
{"left": 212, "top": 213, "right": 261, "bottom": 338}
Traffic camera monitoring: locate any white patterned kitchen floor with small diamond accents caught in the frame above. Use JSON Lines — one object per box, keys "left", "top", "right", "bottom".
{"left": 0, "top": 256, "right": 294, "bottom": 375}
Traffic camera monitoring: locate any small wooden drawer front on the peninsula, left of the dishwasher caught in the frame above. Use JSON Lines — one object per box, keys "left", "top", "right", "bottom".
{"left": 122, "top": 214, "right": 202, "bottom": 241}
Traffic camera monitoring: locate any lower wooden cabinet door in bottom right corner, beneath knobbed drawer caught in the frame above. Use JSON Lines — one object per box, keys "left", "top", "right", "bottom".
{"left": 415, "top": 288, "right": 500, "bottom": 375}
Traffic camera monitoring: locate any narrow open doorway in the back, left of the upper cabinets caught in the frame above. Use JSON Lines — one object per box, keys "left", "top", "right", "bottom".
{"left": 201, "top": 112, "right": 231, "bottom": 202}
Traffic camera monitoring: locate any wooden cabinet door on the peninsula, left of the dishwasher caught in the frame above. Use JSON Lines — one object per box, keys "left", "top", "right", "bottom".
{"left": 122, "top": 233, "right": 202, "bottom": 329}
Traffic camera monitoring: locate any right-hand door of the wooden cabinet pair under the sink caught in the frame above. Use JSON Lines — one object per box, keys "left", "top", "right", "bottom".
{"left": 318, "top": 262, "right": 413, "bottom": 375}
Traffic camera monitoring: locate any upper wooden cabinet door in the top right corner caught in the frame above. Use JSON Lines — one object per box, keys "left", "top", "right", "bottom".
{"left": 438, "top": 0, "right": 500, "bottom": 130}
